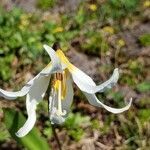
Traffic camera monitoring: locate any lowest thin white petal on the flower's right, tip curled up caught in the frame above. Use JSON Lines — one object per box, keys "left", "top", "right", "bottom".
{"left": 83, "top": 92, "right": 132, "bottom": 114}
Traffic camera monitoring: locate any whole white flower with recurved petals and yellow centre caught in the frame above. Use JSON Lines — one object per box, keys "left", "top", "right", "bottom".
{"left": 0, "top": 45, "right": 132, "bottom": 137}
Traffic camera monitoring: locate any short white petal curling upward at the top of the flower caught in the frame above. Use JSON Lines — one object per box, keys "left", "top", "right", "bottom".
{"left": 40, "top": 45, "right": 62, "bottom": 75}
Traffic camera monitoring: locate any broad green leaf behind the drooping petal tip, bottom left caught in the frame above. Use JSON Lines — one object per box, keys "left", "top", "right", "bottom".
{"left": 3, "top": 109, "right": 50, "bottom": 150}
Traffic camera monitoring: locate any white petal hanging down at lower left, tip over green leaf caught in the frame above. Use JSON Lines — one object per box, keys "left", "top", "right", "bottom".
{"left": 16, "top": 76, "right": 50, "bottom": 137}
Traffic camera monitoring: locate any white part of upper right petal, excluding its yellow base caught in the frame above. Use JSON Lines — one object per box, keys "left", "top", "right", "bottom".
{"left": 71, "top": 67, "right": 119, "bottom": 94}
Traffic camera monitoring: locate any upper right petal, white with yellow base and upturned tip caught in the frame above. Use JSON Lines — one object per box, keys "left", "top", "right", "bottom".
{"left": 48, "top": 50, "right": 119, "bottom": 93}
